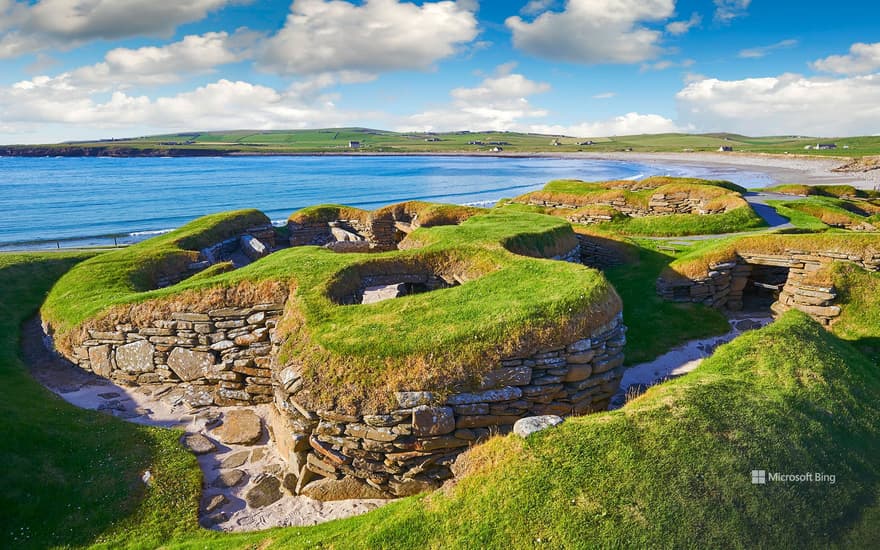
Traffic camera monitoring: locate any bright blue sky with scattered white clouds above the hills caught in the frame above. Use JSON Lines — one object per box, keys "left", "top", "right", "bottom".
{"left": 0, "top": 0, "right": 880, "bottom": 143}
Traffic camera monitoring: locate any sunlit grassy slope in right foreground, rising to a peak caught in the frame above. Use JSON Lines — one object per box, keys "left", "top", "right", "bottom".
{"left": 175, "top": 312, "right": 880, "bottom": 548}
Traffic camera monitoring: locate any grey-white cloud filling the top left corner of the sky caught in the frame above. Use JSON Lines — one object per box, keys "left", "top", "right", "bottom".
{"left": 0, "top": 0, "right": 236, "bottom": 58}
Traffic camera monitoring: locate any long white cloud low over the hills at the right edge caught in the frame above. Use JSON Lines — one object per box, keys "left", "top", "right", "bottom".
{"left": 676, "top": 74, "right": 880, "bottom": 136}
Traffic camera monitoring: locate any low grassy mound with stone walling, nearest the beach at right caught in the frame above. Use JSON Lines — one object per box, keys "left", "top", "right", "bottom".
{"left": 504, "top": 176, "right": 766, "bottom": 237}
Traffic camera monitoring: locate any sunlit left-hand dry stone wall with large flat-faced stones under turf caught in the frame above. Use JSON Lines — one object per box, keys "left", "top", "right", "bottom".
{"left": 52, "top": 303, "right": 284, "bottom": 406}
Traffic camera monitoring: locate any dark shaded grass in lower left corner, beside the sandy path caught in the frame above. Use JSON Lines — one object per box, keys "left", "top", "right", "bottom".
{"left": 0, "top": 253, "right": 202, "bottom": 548}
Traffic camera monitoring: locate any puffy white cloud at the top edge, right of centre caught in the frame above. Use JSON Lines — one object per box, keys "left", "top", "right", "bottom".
{"left": 506, "top": 0, "right": 675, "bottom": 63}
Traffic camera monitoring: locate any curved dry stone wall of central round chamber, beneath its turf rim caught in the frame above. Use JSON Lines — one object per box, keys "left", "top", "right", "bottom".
{"left": 272, "top": 314, "right": 626, "bottom": 498}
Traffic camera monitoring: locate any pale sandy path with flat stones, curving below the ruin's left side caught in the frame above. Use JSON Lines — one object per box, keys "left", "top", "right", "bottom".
{"left": 22, "top": 319, "right": 390, "bottom": 531}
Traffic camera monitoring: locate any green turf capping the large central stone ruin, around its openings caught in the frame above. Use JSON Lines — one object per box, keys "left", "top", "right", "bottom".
{"left": 42, "top": 207, "right": 620, "bottom": 409}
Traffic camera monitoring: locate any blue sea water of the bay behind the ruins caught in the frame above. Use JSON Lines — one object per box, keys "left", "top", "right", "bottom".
{"left": 0, "top": 156, "right": 772, "bottom": 250}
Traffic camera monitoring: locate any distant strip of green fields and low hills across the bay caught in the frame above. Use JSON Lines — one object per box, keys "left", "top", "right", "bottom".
{"left": 10, "top": 128, "right": 880, "bottom": 157}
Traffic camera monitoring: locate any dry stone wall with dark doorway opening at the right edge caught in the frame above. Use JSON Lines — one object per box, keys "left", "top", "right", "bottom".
{"left": 657, "top": 250, "right": 880, "bottom": 325}
